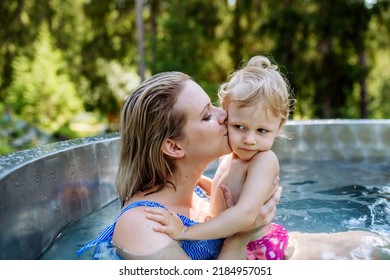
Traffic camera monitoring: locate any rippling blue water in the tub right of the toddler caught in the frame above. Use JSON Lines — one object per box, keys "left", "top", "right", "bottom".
{"left": 277, "top": 161, "right": 390, "bottom": 235}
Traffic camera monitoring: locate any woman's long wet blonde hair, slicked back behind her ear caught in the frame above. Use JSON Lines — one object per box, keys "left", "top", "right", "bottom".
{"left": 116, "top": 72, "right": 192, "bottom": 206}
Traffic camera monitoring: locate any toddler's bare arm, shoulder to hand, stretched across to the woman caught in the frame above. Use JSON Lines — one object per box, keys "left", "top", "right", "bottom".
{"left": 148, "top": 151, "right": 279, "bottom": 240}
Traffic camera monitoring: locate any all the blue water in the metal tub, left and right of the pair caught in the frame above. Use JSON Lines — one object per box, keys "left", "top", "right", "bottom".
{"left": 40, "top": 160, "right": 390, "bottom": 260}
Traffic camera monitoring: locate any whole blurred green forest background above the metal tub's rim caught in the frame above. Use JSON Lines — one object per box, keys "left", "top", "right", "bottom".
{"left": 0, "top": 0, "right": 390, "bottom": 155}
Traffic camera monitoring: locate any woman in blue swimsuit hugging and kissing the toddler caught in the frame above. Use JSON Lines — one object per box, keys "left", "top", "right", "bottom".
{"left": 78, "top": 72, "right": 281, "bottom": 259}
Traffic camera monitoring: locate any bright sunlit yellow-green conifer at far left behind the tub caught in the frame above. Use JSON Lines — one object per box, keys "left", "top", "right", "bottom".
{"left": 7, "top": 25, "right": 82, "bottom": 133}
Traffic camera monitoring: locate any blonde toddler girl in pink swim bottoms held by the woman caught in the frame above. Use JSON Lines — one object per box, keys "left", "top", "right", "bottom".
{"left": 146, "top": 56, "right": 293, "bottom": 259}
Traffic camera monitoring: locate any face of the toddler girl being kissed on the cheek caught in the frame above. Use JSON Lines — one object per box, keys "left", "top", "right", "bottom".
{"left": 228, "top": 103, "right": 282, "bottom": 160}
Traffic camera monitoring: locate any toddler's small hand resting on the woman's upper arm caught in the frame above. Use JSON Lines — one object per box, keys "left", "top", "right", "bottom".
{"left": 145, "top": 207, "right": 187, "bottom": 240}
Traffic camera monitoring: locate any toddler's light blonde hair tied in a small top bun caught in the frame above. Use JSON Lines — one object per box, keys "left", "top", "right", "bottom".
{"left": 218, "top": 56, "right": 295, "bottom": 137}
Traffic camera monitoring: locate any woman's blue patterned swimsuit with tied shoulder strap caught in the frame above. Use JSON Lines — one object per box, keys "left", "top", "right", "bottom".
{"left": 76, "top": 187, "right": 224, "bottom": 260}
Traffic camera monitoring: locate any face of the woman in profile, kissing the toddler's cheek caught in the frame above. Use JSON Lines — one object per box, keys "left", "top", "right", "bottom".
{"left": 176, "top": 80, "right": 231, "bottom": 161}
